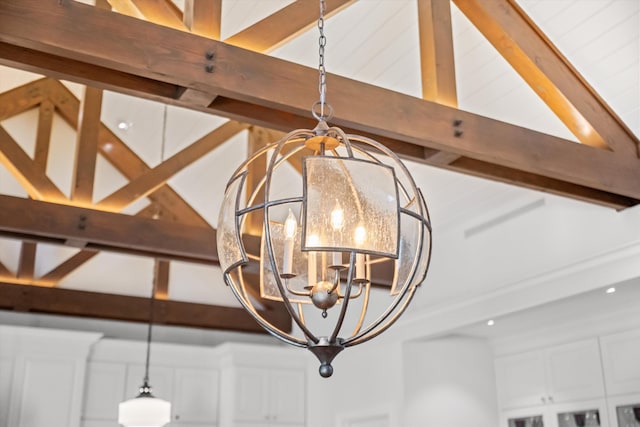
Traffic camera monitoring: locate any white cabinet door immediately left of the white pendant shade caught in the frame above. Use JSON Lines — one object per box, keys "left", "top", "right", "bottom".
{"left": 82, "top": 362, "right": 127, "bottom": 420}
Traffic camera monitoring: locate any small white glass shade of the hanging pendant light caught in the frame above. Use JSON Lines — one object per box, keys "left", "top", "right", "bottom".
{"left": 118, "top": 394, "right": 171, "bottom": 427}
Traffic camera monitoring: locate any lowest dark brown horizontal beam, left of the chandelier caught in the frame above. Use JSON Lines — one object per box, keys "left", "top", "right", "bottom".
{"left": 0, "top": 283, "right": 291, "bottom": 333}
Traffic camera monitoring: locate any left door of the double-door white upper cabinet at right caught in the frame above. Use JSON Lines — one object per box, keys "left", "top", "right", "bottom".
{"left": 496, "top": 351, "right": 547, "bottom": 408}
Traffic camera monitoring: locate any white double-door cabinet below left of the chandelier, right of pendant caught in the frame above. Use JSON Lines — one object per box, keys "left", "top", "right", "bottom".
{"left": 220, "top": 344, "right": 306, "bottom": 427}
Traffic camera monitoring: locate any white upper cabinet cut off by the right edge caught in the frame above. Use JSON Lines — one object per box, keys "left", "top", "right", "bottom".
{"left": 600, "top": 330, "right": 640, "bottom": 396}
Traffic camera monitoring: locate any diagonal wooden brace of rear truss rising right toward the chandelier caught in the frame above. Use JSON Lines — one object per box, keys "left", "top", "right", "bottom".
{"left": 96, "top": 121, "right": 249, "bottom": 212}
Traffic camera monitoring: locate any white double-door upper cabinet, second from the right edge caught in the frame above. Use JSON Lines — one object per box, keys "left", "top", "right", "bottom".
{"left": 495, "top": 339, "right": 605, "bottom": 409}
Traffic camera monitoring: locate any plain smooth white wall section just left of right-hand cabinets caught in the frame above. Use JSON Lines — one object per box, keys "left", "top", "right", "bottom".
{"left": 402, "top": 336, "right": 498, "bottom": 427}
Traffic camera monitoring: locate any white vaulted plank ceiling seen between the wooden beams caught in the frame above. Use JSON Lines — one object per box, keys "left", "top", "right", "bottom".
{"left": 0, "top": 0, "right": 640, "bottom": 342}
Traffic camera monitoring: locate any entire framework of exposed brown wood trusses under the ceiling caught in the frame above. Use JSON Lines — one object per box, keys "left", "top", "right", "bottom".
{"left": 0, "top": 0, "right": 640, "bottom": 331}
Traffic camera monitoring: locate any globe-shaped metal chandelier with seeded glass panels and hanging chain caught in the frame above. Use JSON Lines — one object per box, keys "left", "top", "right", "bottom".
{"left": 217, "top": 0, "right": 431, "bottom": 377}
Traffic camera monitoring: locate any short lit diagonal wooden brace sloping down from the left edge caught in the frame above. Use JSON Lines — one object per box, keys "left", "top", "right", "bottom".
{"left": 0, "top": 126, "right": 68, "bottom": 203}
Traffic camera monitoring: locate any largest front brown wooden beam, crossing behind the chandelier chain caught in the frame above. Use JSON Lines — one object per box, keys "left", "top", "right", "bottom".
{"left": 0, "top": 0, "right": 640, "bottom": 207}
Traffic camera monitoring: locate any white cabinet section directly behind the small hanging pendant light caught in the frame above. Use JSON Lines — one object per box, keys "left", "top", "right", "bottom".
{"left": 82, "top": 340, "right": 219, "bottom": 427}
